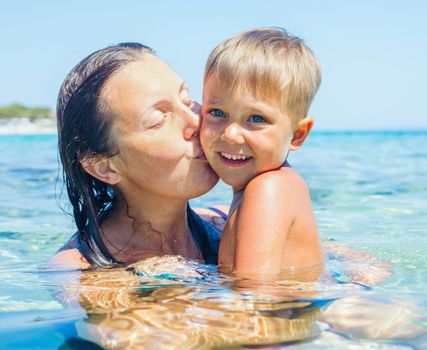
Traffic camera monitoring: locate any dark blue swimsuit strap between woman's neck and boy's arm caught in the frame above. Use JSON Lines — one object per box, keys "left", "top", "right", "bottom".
{"left": 187, "top": 205, "right": 221, "bottom": 265}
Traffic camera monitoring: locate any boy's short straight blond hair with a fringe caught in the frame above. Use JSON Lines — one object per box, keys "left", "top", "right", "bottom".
{"left": 204, "top": 28, "right": 320, "bottom": 122}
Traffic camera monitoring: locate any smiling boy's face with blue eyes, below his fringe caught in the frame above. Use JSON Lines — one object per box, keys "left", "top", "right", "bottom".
{"left": 200, "top": 76, "right": 293, "bottom": 191}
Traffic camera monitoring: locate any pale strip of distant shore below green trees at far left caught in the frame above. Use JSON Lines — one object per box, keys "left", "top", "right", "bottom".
{"left": 0, "top": 117, "right": 56, "bottom": 135}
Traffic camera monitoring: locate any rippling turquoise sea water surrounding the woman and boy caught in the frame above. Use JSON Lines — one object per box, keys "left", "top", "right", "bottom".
{"left": 0, "top": 131, "right": 427, "bottom": 349}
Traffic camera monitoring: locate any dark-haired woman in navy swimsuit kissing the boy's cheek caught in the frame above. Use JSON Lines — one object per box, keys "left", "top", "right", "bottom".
{"left": 52, "top": 43, "right": 227, "bottom": 268}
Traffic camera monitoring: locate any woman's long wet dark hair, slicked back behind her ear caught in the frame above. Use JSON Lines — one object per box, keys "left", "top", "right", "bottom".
{"left": 57, "top": 43, "right": 154, "bottom": 265}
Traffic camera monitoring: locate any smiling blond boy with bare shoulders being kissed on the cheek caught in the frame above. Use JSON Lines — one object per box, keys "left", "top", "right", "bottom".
{"left": 200, "top": 28, "right": 323, "bottom": 278}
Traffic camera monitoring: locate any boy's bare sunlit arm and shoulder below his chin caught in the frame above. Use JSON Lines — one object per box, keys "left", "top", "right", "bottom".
{"left": 233, "top": 168, "right": 311, "bottom": 279}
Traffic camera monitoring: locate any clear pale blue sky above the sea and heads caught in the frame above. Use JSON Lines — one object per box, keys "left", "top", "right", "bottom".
{"left": 0, "top": 0, "right": 427, "bottom": 130}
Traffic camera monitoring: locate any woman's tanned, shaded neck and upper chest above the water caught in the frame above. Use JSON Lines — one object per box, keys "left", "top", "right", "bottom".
{"left": 102, "top": 194, "right": 200, "bottom": 263}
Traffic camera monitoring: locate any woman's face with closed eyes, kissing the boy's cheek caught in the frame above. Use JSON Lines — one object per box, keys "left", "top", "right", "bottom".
{"left": 102, "top": 54, "right": 218, "bottom": 200}
